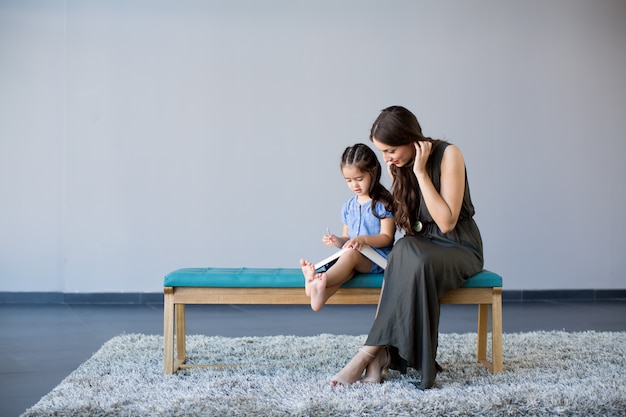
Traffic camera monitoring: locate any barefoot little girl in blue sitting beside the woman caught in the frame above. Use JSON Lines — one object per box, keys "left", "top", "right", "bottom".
{"left": 300, "top": 143, "right": 395, "bottom": 311}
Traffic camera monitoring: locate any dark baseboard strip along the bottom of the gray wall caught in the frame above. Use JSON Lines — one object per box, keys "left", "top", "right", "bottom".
{"left": 0, "top": 289, "right": 626, "bottom": 304}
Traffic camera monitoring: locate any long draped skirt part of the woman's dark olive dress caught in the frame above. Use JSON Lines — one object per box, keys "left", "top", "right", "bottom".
{"left": 365, "top": 236, "right": 471, "bottom": 389}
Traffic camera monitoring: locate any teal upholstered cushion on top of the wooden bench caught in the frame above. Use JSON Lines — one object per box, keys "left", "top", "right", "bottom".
{"left": 163, "top": 268, "right": 502, "bottom": 288}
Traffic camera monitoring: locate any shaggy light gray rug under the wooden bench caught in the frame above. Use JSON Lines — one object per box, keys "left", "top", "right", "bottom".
{"left": 23, "top": 332, "right": 626, "bottom": 417}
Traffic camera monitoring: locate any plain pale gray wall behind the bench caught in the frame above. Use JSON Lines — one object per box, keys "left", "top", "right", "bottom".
{"left": 0, "top": 0, "right": 626, "bottom": 292}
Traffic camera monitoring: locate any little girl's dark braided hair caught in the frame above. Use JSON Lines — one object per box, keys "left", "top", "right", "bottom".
{"left": 340, "top": 143, "right": 393, "bottom": 219}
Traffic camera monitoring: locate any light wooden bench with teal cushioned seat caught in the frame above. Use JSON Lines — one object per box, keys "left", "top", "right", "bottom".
{"left": 163, "top": 268, "right": 502, "bottom": 374}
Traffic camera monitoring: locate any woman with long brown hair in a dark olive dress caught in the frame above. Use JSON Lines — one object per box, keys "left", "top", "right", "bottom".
{"left": 331, "top": 106, "right": 483, "bottom": 389}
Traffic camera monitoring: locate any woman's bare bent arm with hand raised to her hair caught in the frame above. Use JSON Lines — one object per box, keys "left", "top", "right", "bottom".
{"left": 413, "top": 142, "right": 465, "bottom": 233}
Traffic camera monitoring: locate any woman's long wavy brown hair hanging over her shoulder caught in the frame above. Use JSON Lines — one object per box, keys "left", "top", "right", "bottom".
{"left": 370, "top": 106, "right": 442, "bottom": 235}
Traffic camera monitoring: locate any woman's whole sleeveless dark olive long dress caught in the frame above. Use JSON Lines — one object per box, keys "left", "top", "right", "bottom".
{"left": 365, "top": 142, "right": 483, "bottom": 389}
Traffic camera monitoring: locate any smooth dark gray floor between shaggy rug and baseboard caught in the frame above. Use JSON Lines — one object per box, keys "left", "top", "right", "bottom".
{"left": 0, "top": 300, "right": 626, "bottom": 417}
